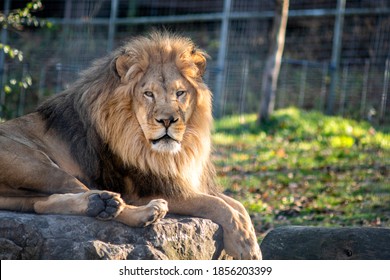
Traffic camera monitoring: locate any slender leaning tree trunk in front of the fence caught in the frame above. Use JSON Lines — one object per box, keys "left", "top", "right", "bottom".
{"left": 258, "top": 0, "right": 289, "bottom": 123}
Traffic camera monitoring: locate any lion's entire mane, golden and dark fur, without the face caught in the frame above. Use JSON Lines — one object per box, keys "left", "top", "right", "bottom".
{"left": 38, "top": 32, "right": 215, "bottom": 197}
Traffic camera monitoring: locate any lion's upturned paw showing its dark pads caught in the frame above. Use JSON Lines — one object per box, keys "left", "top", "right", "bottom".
{"left": 86, "top": 191, "right": 124, "bottom": 220}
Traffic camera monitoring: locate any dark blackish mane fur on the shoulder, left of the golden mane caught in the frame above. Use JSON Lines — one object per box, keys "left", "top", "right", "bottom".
{"left": 37, "top": 57, "right": 124, "bottom": 191}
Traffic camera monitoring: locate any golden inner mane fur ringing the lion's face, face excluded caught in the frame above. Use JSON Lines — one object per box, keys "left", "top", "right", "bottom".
{"left": 92, "top": 33, "right": 212, "bottom": 193}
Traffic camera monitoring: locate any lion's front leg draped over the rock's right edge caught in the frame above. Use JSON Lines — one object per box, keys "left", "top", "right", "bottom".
{"left": 168, "top": 194, "right": 262, "bottom": 260}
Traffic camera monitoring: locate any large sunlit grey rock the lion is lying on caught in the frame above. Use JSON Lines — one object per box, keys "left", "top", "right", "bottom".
{"left": 0, "top": 211, "right": 227, "bottom": 260}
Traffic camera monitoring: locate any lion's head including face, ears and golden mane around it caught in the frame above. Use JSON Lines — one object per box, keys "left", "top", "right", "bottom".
{"left": 97, "top": 33, "right": 212, "bottom": 179}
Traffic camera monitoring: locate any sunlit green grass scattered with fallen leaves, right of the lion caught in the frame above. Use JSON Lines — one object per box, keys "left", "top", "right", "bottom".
{"left": 213, "top": 109, "right": 390, "bottom": 242}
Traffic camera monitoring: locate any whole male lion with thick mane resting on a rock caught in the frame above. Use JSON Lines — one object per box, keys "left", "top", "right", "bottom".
{"left": 0, "top": 32, "right": 261, "bottom": 259}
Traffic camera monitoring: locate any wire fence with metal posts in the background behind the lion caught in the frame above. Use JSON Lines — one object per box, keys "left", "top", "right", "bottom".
{"left": 0, "top": 0, "right": 390, "bottom": 125}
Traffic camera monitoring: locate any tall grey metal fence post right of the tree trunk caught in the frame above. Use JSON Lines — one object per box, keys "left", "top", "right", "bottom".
{"left": 326, "top": 0, "right": 346, "bottom": 115}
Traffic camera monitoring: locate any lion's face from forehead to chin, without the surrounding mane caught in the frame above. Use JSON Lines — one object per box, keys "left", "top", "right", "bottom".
{"left": 133, "top": 63, "right": 196, "bottom": 153}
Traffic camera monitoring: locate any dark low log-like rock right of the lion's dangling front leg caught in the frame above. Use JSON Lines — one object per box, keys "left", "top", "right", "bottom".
{"left": 260, "top": 226, "right": 390, "bottom": 260}
